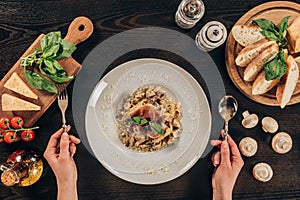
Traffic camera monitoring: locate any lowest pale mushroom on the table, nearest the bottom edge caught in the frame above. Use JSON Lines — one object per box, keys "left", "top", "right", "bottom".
{"left": 252, "top": 163, "right": 273, "bottom": 182}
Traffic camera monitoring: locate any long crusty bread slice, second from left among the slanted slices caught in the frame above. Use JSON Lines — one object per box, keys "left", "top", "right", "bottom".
{"left": 244, "top": 43, "right": 279, "bottom": 81}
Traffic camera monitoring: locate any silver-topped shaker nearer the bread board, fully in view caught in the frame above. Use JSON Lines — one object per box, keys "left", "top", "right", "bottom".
{"left": 195, "top": 21, "right": 227, "bottom": 51}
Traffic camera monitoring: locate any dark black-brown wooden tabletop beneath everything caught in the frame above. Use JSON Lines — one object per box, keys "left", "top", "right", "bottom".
{"left": 0, "top": 0, "right": 300, "bottom": 199}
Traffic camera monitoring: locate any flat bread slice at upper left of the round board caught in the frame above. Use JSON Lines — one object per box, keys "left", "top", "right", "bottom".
{"left": 231, "top": 25, "right": 265, "bottom": 47}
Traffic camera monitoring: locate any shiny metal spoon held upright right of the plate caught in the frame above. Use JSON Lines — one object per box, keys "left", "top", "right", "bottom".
{"left": 218, "top": 95, "right": 238, "bottom": 140}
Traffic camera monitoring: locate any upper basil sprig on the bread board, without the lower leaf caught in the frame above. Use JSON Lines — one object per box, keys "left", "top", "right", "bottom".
{"left": 252, "top": 16, "right": 290, "bottom": 47}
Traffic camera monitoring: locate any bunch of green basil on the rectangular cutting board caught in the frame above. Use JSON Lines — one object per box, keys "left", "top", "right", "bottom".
{"left": 21, "top": 31, "right": 76, "bottom": 93}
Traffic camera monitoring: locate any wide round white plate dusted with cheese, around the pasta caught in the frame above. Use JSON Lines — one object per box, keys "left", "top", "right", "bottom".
{"left": 85, "top": 58, "right": 211, "bottom": 184}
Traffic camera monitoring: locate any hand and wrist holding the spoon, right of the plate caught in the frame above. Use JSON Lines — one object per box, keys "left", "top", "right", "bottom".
{"left": 211, "top": 131, "right": 244, "bottom": 200}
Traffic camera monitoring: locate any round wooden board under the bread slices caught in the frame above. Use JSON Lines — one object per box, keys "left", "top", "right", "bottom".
{"left": 225, "top": 1, "right": 300, "bottom": 106}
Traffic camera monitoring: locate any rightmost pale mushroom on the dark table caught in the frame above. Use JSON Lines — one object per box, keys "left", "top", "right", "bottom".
{"left": 272, "top": 132, "right": 293, "bottom": 154}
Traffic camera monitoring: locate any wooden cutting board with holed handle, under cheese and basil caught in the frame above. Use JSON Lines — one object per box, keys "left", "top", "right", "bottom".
{"left": 0, "top": 17, "right": 94, "bottom": 127}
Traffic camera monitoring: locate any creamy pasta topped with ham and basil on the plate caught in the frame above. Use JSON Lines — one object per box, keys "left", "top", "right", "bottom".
{"left": 117, "top": 86, "right": 182, "bottom": 152}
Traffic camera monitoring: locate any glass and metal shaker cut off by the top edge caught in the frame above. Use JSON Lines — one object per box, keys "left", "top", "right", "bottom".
{"left": 175, "top": 0, "right": 205, "bottom": 29}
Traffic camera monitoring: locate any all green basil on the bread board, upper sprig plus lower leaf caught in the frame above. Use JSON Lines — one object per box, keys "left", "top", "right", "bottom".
{"left": 252, "top": 16, "right": 290, "bottom": 81}
